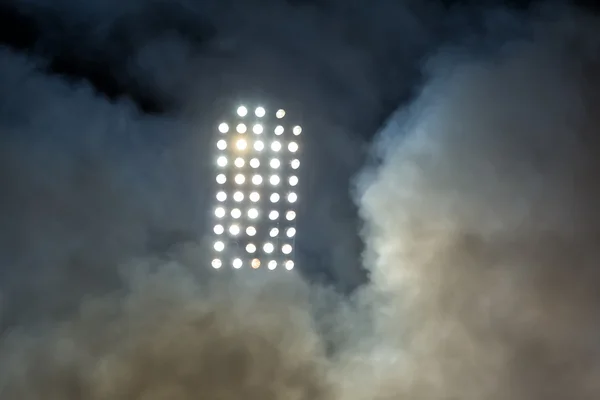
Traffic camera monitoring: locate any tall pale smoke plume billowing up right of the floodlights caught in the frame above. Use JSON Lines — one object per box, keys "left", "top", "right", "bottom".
{"left": 362, "top": 7, "right": 600, "bottom": 400}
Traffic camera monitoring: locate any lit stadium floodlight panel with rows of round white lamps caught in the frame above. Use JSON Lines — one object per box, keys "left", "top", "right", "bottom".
{"left": 211, "top": 105, "right": 302, "bottom": 271}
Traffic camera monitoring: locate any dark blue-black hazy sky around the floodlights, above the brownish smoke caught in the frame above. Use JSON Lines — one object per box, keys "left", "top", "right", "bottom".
{"left": 0, "top": 0, "right": 596, "bottom": 322}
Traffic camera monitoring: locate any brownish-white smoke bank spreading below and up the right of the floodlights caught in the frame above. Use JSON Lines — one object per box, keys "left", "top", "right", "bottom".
{"left": 0, "top": 2, "right": 600, "bottom": 400}
